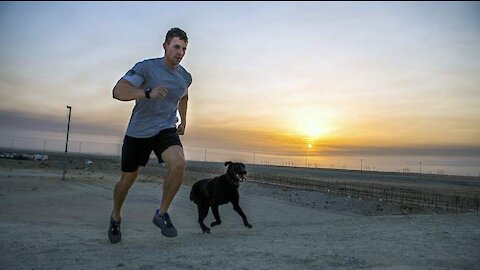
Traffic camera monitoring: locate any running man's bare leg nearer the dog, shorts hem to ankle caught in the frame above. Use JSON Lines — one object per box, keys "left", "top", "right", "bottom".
{"left": 160, "top": 145, "right": 185, "bottom": 214}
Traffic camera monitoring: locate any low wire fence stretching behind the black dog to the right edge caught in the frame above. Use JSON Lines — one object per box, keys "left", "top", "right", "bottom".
{"left": 189, "top": 167, "right": 480, "bottom": 213}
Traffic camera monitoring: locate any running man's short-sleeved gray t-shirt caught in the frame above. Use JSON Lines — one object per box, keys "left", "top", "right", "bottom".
{"left": 122, "top": 57, "right": 192, "bottom": 138}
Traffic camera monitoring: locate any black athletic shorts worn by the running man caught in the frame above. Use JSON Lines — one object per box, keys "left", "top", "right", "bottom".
{"left": 122, "top": 128, "right": 182, "bottom": 172}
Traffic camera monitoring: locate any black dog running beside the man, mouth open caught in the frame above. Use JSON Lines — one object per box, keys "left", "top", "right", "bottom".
{"left": 190, "top": 161, "right": 252, "bottom": 233}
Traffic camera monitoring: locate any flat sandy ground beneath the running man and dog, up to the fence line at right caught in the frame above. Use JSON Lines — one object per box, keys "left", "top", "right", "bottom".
{"left": 0, "top": 158, "right": 480, "bottom": 269}
